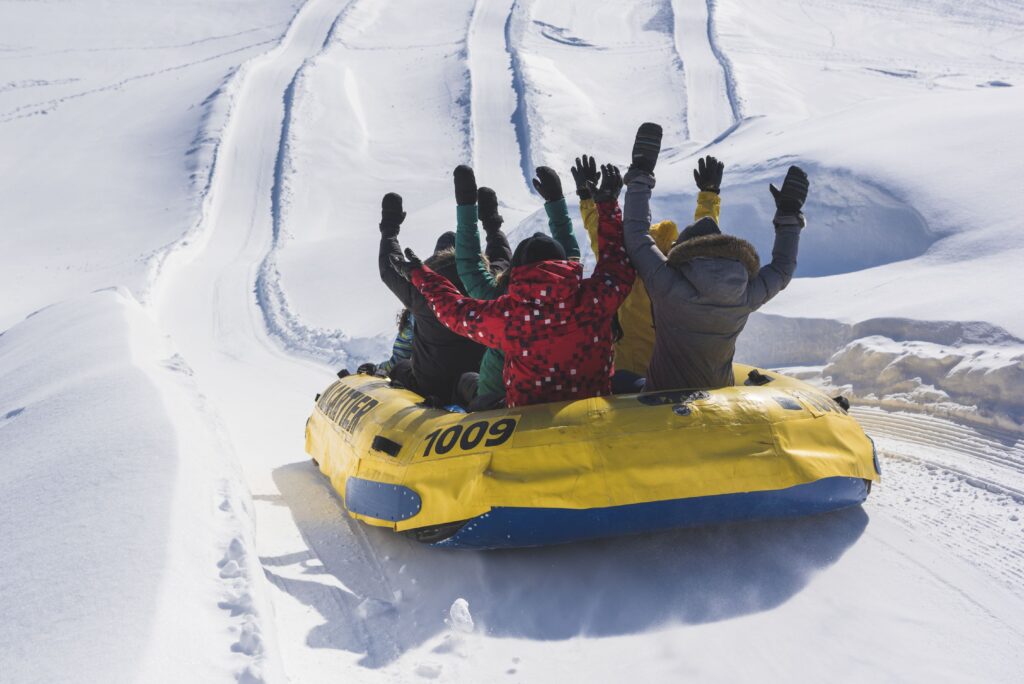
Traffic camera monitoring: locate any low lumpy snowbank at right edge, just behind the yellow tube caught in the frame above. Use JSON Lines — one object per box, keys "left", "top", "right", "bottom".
{"left": 736, "top": 313, "right": 1024, "bottom": 429}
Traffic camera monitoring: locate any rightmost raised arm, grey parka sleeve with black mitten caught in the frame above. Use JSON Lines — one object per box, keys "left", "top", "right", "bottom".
{"left": 746, "top": 166, "right": 810, "bottom": 309}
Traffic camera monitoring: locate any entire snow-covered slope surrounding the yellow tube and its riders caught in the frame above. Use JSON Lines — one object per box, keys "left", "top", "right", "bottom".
{"left": 0, "top": 0, "right": 1024, "bottom": 682}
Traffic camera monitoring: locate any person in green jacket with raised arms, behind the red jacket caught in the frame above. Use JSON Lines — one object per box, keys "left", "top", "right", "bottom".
{"left": 453, "top": 165, "right": 580, "bottom": 411}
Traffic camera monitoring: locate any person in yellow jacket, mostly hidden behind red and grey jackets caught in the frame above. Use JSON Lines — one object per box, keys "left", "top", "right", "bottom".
{"left": 571, "top": 155, "right": 725, "bottom": 382}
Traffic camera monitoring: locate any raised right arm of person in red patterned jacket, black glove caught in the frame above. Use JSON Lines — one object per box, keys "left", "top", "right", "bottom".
{"left": 583, "top": 164, "right": 636, "bottom": 315}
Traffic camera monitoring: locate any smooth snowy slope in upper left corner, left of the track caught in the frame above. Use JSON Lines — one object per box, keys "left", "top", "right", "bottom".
{"left": 0, "top": 0, "right": 296, "bottom": 328}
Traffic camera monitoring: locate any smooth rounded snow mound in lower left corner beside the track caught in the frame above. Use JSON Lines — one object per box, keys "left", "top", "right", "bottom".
{"left": 0, "top": 290, "right": 275, "bottom": 682}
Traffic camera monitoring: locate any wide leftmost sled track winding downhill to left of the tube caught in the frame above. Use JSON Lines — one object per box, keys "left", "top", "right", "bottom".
{"left": 151, "top": 0, "right": 405, "bottom": 671}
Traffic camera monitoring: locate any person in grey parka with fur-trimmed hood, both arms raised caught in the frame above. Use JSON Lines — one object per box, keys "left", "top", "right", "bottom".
{"left": 623, "top": 123, "right": 809, "bottom": 392}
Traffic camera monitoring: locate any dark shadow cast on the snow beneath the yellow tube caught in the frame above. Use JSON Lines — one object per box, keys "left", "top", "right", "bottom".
{"left": 262, "top": 463, "right": 868, "bottom": 668}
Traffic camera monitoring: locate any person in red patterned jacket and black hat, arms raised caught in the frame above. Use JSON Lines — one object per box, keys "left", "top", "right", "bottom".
{"left": 392, "top": 165, "right": 636, "bottom": 407}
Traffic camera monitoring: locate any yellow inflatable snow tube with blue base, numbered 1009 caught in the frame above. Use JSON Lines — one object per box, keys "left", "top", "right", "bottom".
{"left": 306, "top": 365, "right": 880, "bottom": 548}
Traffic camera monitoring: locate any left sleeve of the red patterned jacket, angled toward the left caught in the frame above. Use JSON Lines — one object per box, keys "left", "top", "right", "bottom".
{"left": 405, "top": 266, "right": 509, "bottom": 349}
